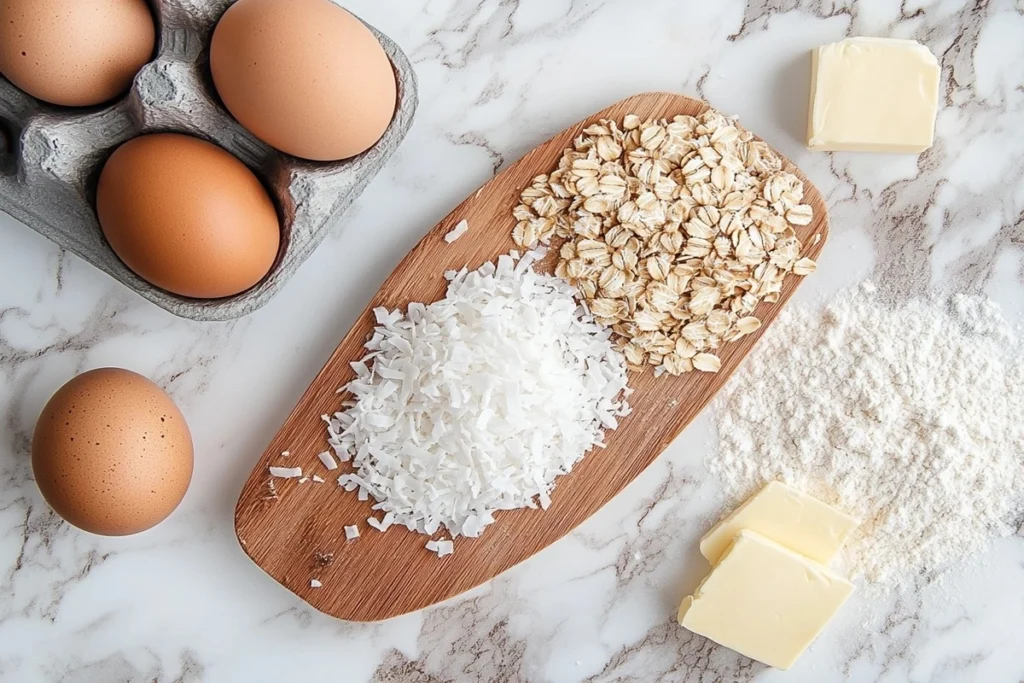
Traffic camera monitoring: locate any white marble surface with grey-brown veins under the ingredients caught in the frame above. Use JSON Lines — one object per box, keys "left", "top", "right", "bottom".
{"left": 0, "top": 0, "right": 1024, "bottom": 683}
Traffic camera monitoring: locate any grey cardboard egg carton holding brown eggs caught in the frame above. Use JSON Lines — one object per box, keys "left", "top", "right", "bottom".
{"left": 0, "top": 0, "right": 417, "bottom": 321}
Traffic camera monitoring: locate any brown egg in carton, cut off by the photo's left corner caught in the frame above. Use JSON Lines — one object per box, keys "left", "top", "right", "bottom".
{"left": 0, "top": 0, "right": 157, "bottom": 106}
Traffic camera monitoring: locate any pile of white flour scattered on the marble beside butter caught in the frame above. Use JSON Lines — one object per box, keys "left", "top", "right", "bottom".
{"left": 709, "top": 284, "right": 1024, "bottom": 585}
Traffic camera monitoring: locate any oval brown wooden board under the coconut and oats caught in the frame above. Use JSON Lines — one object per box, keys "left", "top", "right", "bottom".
{"left": 234, "top": 93, "right": 828, "bottom": 622}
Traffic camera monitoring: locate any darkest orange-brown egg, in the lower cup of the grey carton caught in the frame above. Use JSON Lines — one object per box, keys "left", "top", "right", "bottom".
{"left": 96, "top": 133, "right": 281, "bottom": 299}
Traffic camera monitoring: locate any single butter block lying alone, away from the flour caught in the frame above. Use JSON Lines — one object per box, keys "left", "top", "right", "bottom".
{"left": 807, "top": 38, "right": 941, "bottom": 153}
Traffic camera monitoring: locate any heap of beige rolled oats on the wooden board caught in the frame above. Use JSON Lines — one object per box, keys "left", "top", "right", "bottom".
{"left": 512, "top": 110, "right": 815, "bottom": 375}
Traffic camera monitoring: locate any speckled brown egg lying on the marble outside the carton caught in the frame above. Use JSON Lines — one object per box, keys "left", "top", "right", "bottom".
{"left": 32, "top": 368, "right": 193, "bottom": 536}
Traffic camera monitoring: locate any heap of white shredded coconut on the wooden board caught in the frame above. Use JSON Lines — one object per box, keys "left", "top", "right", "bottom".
{"left": 328, "top": 252, "right": 629, "bottom": 537}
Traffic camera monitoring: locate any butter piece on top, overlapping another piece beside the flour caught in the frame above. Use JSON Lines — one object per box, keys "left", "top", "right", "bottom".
{"left": 678, "top": 530, "right": 854, "bottom": 669}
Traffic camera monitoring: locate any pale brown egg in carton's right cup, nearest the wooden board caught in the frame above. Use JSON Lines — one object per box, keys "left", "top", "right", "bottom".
{"left": 210, "top": 0, "right": 397, "bottom": 161}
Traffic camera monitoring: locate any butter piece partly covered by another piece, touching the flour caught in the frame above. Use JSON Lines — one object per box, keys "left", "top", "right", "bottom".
{"left": 700, "top": 481, "right": 860, "bottom": 564}
